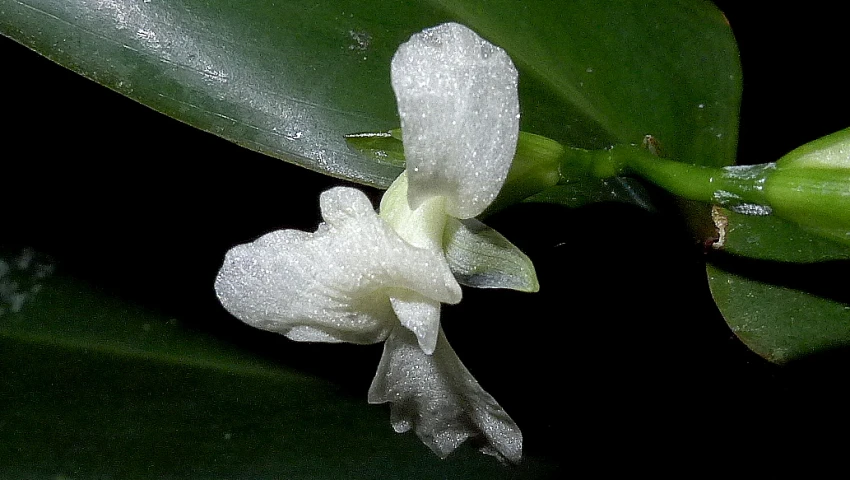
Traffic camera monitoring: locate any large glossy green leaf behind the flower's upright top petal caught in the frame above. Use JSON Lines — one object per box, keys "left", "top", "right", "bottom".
{"left": 0, "top": 0, "right": 740, "bottom": 191}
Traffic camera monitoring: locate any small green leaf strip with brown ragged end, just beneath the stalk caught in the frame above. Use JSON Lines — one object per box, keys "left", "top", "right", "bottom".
{"left": 712, "top": 207, "right": 850, "bottom": 263}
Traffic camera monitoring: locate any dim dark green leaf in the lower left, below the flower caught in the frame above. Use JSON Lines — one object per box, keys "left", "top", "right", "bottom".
{"left": 0, "top": 250, "right": 554, "bottom": 479}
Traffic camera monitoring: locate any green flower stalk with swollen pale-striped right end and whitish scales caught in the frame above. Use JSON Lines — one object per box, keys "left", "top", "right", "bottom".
{"left": 548, "top": 129, "right": 850, "bottom": 243}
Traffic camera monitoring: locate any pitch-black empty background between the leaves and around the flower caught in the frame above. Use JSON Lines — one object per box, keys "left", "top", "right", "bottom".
{"left": 0, "top": 1, "right": 850, "bottom": 464}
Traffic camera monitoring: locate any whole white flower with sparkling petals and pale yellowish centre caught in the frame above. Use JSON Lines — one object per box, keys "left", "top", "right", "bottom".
{"left": 215, "top": 23, "right": 522, "bottom": 462}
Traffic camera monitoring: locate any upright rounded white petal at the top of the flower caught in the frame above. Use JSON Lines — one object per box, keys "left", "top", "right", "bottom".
{"left": 391, "top": 23, "right": 519, "bottom": 218}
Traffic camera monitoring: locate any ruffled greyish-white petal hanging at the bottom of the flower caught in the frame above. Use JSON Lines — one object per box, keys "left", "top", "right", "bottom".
{"left": 369, "top": 328, "right": 522, "bottom": 462}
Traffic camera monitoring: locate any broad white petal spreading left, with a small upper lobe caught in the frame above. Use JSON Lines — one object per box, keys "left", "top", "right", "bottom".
{"left": 215, "top": 187, "right": 461, "bottom": 343}
